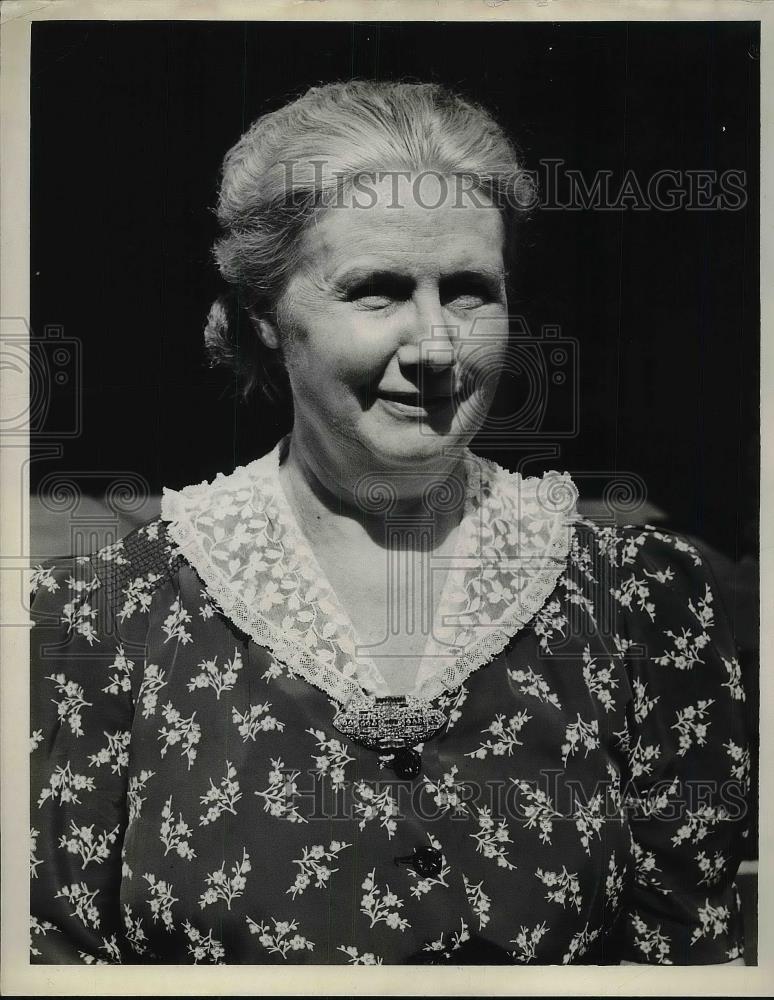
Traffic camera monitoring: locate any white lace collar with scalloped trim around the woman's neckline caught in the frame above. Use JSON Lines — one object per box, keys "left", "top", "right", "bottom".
{"left": 161, "top": 439, "right": 578, "bottom": 705}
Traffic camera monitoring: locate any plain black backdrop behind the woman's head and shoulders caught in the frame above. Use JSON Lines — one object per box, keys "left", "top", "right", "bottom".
{"left": 31, "top": 22, "right": 759, "bottom": 560}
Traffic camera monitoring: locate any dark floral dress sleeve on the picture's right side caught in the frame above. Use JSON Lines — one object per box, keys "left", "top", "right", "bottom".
{"left": 611, "top": 527, "right": 750, "bottom": 965}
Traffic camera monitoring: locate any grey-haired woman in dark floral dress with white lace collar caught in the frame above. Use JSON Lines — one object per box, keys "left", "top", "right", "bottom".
{"left": 31, "top": 81, "right": 749, "bottom": 965}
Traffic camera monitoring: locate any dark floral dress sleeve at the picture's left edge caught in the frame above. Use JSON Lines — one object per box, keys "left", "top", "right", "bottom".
{"left": 30, "top": 558, "right": 133, "bottom": 964}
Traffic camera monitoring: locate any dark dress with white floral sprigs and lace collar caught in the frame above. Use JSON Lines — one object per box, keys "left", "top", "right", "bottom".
{"left": 30, "top": 442, "right": 750, "bottom": 965}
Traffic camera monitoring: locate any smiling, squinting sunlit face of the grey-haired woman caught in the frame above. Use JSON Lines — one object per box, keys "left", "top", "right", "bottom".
{"left": 270, "top": 178, "right": 508, "bottom": 469}
